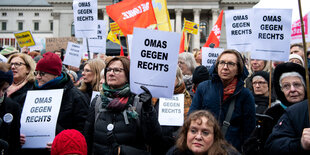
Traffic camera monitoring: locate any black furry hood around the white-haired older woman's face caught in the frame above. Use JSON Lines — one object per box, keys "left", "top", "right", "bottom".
{"left": 272, "top": 62, "right": 307, "bottom": 106}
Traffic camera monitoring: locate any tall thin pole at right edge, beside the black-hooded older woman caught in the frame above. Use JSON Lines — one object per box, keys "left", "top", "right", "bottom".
{"left": 298, "top": 0, "right": 310, "bottom": 121}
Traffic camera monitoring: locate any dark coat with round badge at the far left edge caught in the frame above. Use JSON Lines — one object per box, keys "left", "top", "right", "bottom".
{"left": 0, "top": 98, "right": 21, "bottom": 155}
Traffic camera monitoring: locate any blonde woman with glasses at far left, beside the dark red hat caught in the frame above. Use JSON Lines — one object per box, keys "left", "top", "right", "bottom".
{"left": 7, "top": 53, "right": 36, "bottom": 108}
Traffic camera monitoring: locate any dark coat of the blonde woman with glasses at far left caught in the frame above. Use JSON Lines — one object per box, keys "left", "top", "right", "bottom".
{"left": 10, "top": 82, "right": 33, "bottom": 110}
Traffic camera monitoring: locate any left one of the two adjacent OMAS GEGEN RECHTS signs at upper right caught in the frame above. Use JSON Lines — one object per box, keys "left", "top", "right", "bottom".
{"left": 225, "top": 9, "right": 253, "bottom": 52}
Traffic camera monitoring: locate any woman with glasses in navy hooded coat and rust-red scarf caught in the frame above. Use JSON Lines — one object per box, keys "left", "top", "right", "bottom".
{"left": 189, "top": 50, "right": 255, "bottom": 151}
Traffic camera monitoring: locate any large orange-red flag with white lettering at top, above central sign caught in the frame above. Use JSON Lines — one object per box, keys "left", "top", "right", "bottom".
{"left": 106, "top": 0, "right": 157, "bottom": 36}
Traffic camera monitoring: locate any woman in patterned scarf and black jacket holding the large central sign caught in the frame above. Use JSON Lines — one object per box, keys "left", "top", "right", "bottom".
{"left": 84, "top": 57, "right": 161, "bottom": 155}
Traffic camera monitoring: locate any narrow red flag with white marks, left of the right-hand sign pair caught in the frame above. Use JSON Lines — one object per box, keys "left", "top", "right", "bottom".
{"left": 203, "top": 10, "right": 223, "bottom": 48}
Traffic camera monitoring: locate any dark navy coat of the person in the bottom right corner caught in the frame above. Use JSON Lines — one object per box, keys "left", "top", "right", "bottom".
{"left": 265, "top": 100, "right": 310, "bottom": 155}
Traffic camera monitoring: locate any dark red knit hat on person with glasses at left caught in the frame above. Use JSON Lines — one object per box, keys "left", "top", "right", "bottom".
{"left": 36, "top": 52, "right": 62, "bottom": 75}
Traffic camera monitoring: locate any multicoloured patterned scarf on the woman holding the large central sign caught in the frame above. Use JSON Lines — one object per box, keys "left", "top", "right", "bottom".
{"left": 101, "top": 84, "right": 133, "bottom": 111}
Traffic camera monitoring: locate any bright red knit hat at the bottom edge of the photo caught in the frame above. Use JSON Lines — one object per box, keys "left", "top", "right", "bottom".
{"left": 51, "top": 129, "right": 87, "bottom": 155}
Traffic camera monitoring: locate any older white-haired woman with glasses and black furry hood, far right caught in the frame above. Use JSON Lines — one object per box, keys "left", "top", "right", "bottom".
{"left": 265, "top": 62, "right": 307, "bottom": 152}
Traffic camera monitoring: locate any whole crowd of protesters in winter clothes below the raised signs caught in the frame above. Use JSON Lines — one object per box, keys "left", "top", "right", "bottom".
{"left": 0, "top": 44, "right": 310, "bottom": 155}
